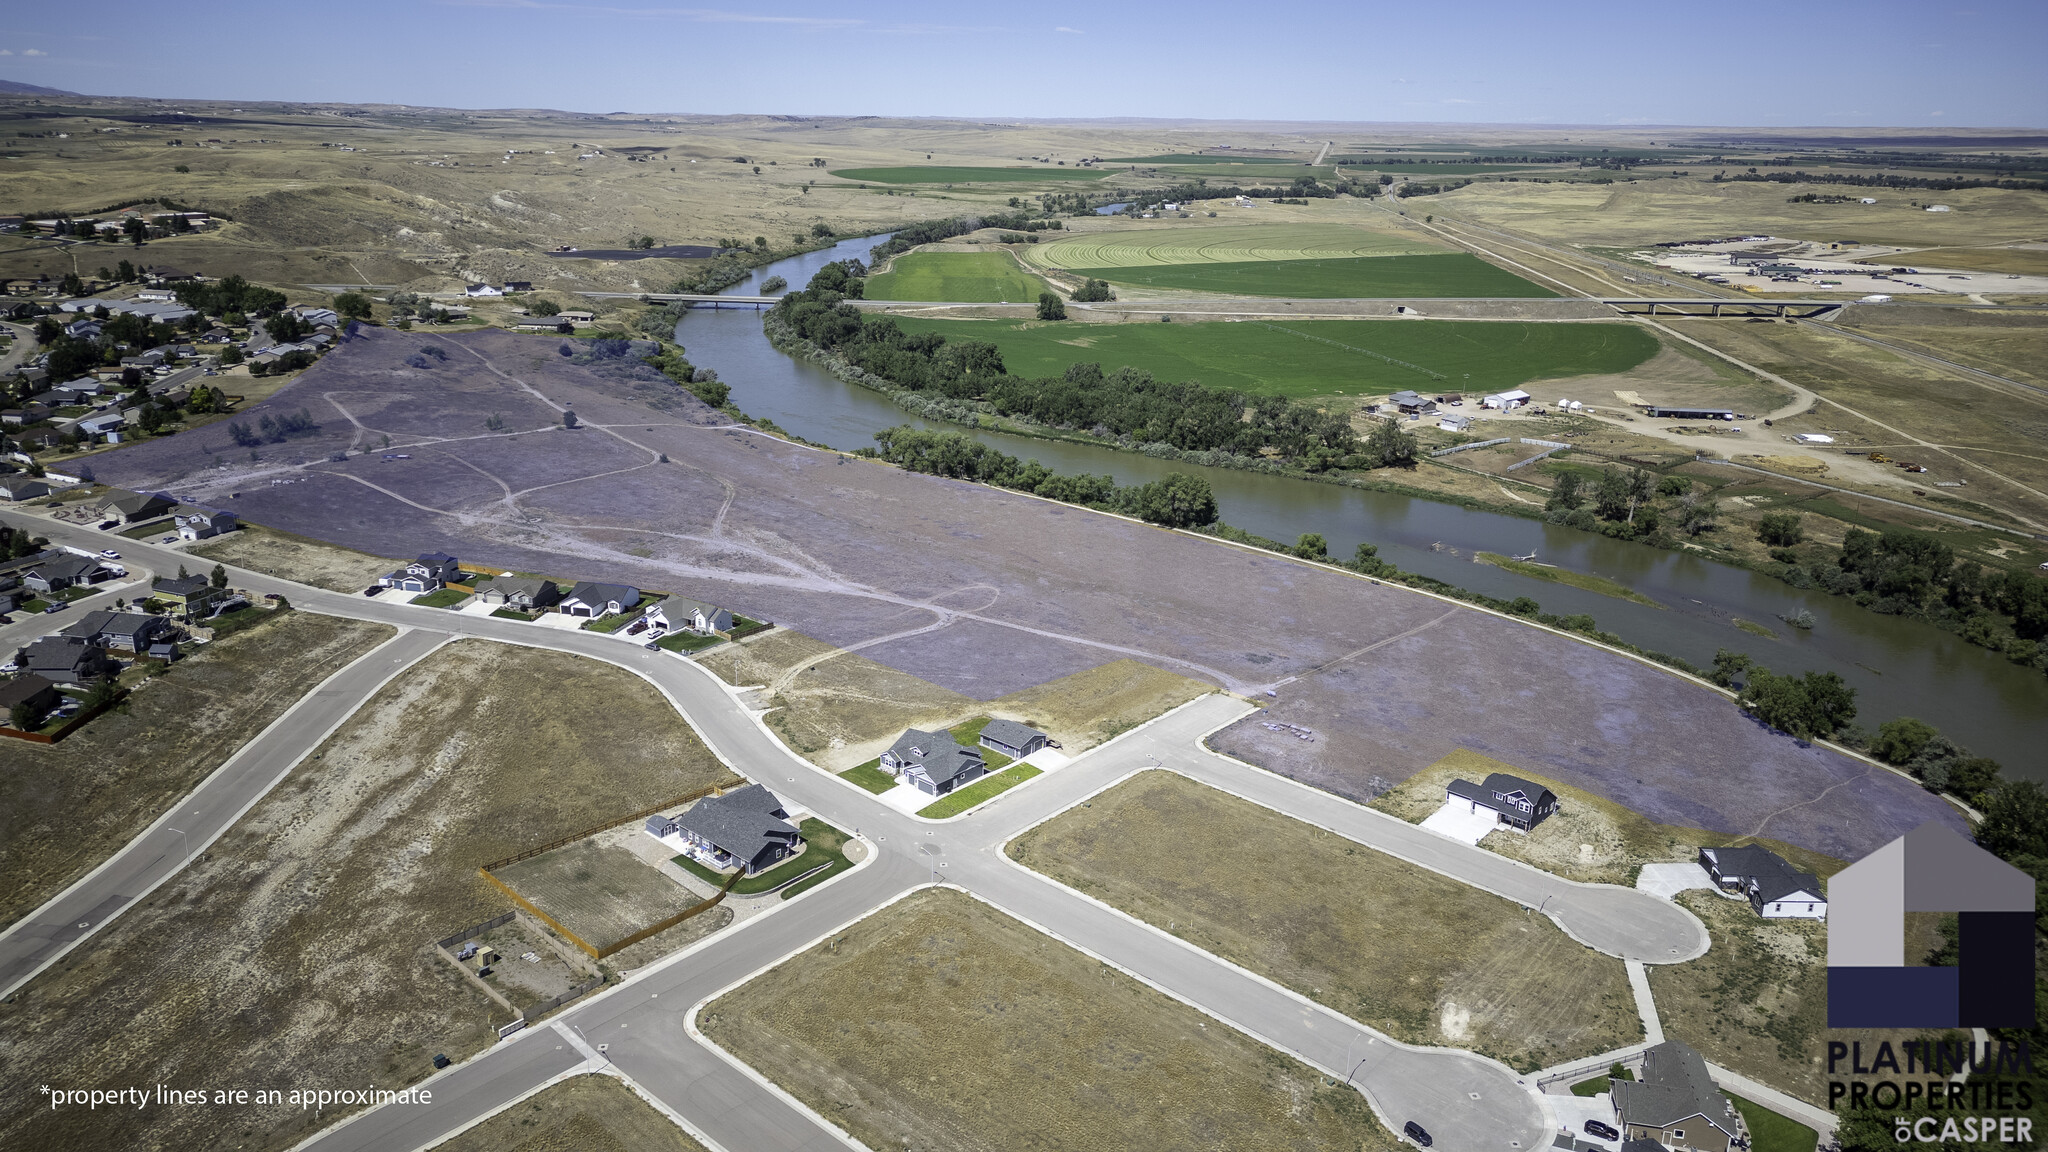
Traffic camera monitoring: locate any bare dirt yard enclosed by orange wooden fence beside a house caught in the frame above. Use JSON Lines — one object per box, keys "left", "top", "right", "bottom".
{"left": 492, "top": 840, "right": 702, "bottom": 949}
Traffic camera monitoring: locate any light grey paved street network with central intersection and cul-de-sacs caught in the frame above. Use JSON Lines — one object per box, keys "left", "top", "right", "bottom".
{"left": 4, "top": 510, "right": 1704, "bottom": 1152}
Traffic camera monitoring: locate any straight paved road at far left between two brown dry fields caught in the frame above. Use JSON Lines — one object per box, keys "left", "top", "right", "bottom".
{"left": 0, "top": 619, "right": 449, "bottom": 996}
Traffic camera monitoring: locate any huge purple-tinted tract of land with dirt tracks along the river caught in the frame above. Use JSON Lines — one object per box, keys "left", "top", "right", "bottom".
{"left": 83, "top": 328, "right": 1956, "bottom": 855}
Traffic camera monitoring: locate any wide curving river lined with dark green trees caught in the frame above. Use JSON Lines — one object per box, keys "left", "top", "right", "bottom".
{"left": 676, "top": 236, "right": 2048, "bottom": 770}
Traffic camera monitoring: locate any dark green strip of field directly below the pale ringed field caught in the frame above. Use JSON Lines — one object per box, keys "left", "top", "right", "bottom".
{"left": 1073, "top": 252, "right": 1556, "bottom": 299}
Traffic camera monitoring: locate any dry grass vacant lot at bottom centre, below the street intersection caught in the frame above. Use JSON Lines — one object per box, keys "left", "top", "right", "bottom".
{"left": 700, "top": 890, "right": 1395, "bottom": 1152}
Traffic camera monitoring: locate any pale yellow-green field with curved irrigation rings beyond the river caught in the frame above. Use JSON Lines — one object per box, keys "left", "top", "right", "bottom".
{"left": 1024, "top": 223, "right": 1448, "bottom": 269}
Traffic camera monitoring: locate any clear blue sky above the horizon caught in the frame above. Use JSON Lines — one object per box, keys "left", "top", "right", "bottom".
{"left": 0, "top": 0, "right": 2048, "bottom": 127}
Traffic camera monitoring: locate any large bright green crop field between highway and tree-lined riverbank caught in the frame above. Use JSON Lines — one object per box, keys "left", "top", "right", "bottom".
{"left": 895, "top": 316, "right": 1657, "bottom": 398}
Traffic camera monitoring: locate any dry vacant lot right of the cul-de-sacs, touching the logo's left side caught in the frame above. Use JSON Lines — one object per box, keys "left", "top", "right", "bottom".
{"left": 1651, "top": 892, "right": 1829, "bottom": 1105}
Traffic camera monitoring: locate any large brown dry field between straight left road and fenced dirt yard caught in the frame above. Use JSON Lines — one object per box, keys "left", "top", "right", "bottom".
{"left": 0, "top": 642, "right": 725, "bottom": 1150}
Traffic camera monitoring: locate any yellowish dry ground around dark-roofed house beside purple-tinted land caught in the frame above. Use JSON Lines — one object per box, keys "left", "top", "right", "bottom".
{"left": 1370, "top": 748, "right": 1847, "bottom": 888}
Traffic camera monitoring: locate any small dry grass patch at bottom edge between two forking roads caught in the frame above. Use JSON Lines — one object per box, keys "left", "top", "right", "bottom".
{"left": 434, "top": 1076, "right": 705, "bottom": 1152}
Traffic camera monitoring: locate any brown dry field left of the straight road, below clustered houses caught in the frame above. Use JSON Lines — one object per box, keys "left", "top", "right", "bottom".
{"left": 0, "top": 613, "right": 397, "bottom": 924}
